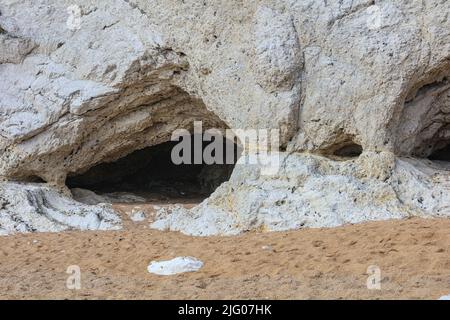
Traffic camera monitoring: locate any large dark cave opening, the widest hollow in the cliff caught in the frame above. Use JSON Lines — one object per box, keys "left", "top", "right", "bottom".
{"left": 66, "top": 135, "right": 240, "bottom": 203}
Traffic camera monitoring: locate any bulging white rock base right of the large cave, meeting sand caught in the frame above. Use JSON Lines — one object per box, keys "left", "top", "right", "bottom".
{"left": 151, "top": 154, "right": 450, "bottom": 236}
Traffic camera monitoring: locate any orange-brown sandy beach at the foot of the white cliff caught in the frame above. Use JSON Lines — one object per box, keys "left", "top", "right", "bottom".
{"left": 0, "top": 211, "right": 450, "bottom": 299}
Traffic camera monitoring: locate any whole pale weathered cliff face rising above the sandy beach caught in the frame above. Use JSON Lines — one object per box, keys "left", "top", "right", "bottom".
{"left": 0, "top": 0, "right": 450, "bottom": 235}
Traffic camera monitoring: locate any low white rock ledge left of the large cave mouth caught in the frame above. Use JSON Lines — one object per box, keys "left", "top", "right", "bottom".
{"left": 0, "top": 183, "right": 121, "bottom": 235}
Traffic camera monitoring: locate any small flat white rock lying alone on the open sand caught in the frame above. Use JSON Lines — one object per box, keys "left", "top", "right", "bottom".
{"left": 147, "top": 257, "right": 203, "bottom": 276}
